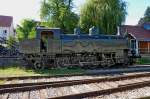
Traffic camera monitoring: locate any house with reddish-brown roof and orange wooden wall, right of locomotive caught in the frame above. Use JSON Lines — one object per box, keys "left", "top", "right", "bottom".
{"left": 120, "top": 23, "right": 150, "bottom": 54}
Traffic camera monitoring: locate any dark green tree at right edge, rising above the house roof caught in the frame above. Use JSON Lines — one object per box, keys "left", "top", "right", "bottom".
{"left": 138, "top": 7, "right": 150, "bottom": 25}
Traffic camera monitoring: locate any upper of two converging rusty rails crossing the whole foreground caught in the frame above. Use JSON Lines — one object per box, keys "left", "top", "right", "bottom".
{"left": 0, "top": 73, "right": 150, "bottom": 88}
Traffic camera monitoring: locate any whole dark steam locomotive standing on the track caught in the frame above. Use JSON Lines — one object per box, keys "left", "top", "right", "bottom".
{"left": 19, "top": 27, "right": 138, "bottom": 69}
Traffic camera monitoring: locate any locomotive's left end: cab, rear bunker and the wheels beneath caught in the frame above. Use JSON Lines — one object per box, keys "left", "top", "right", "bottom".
{"left": 19, "top": 27, "right": 61, "bottom": 69}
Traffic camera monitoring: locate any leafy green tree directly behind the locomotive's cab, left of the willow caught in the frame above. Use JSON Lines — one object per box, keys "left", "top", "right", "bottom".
{"left": 40, "top": 0, "right": 79, "bottom": 32}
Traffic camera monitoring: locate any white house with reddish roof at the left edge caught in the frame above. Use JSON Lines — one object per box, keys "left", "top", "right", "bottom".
{"left": 0, "top": 15, "right": 16, "bottom": 40}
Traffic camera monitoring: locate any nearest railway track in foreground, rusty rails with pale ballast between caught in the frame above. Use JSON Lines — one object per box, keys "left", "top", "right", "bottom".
{"left": 0, "top": 73, "right": 150, "bottom": 99}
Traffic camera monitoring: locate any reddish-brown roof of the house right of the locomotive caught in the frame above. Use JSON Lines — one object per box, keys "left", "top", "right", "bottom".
{"left": 120, "top": 25, "right": 150, "bottom": 41}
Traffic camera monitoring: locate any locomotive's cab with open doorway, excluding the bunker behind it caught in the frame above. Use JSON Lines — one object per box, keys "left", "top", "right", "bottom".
{"left": 36, "top": 27, "right": 61, "bottom": 54}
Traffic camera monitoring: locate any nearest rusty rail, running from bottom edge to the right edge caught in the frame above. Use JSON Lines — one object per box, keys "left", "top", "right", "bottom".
{"left": 48, "top": 81, "right": 150, "bottom": 99}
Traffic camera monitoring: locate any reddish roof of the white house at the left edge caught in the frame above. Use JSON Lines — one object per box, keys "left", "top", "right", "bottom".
{"left": 0, "top": 15, "right": 13, "bottom": 27}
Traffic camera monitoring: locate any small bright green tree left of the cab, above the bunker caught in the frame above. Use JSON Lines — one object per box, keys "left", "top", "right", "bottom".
{"left": 16, "top": 19, "right": 37, "bottom": 40}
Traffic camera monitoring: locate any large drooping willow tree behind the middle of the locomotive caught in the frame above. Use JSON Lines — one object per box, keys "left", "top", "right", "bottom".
{"left": 79, "top": 0, "right": 127, "bottom": 34}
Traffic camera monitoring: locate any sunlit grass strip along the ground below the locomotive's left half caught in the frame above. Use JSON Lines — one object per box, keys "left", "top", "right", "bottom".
{"left": 0, "top": 66, "right": 85, "bottom": 77}
